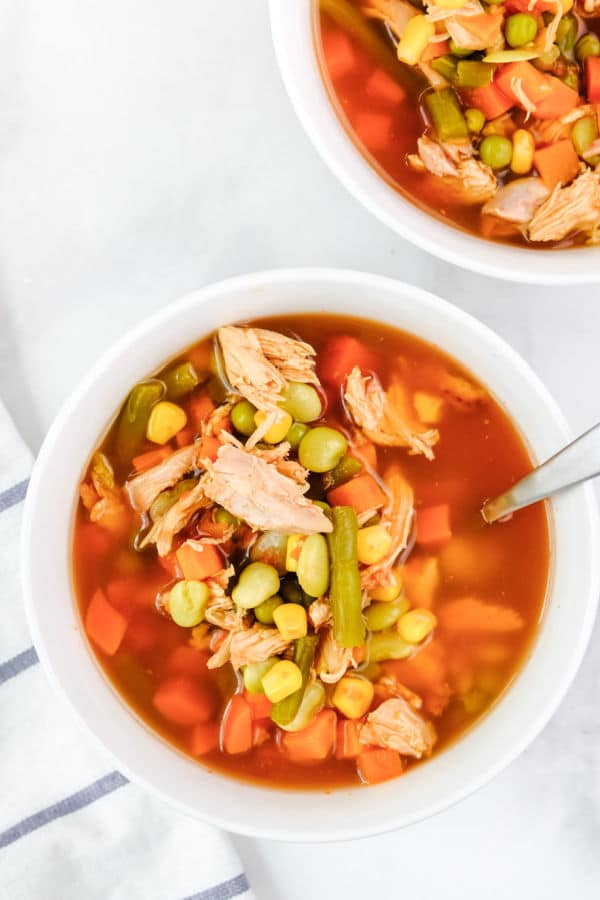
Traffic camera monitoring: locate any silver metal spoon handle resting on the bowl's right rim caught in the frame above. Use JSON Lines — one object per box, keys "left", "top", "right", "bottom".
{"left": 481, "top": 423, "right": 600, "bottom": 524}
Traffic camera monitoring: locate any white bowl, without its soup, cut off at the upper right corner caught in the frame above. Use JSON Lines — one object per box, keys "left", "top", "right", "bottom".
{"left": 270, "top": 0, "right": 600, "bottom": 284}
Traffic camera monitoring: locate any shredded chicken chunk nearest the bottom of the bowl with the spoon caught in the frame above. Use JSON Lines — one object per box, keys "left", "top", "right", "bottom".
{"left": 359, "top": 697, "right": 437, "bottom": 759}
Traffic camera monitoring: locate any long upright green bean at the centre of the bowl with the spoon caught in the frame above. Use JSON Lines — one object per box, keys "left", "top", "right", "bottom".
{"left": 327, "top": 506, "right": 365, "bottom": 647}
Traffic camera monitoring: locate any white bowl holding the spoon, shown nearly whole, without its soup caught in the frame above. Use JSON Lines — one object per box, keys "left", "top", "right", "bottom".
{"left": 22, "top": 269, "right": 599, "bottom": 841}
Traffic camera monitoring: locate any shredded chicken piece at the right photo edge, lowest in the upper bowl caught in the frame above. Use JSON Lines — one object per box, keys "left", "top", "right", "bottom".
{"left": 526, "top": 169, "right": 600, "bottom": 242}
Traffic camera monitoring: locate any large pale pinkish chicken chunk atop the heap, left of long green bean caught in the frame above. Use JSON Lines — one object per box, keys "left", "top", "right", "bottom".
{"left": 204, "top": 444, "right": 333, "bottom": 534}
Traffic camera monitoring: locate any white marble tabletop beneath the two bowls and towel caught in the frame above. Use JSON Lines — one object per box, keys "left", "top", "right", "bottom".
{"left": 0, "top": 0, "right": 600, "bottom": 900}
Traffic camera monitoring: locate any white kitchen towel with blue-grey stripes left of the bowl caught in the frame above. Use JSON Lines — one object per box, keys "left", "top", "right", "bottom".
{"left": 0, "top": 404, "right": 254, "bottom": 900}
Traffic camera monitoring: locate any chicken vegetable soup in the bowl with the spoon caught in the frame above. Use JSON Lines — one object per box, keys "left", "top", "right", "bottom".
{"left": 73, "top": 315, "right": 549, "bottom": 789}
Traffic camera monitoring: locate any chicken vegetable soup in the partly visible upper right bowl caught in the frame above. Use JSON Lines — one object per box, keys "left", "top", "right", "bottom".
{"left": 315, "top": 0, "right": 600, "bottom": 248}
